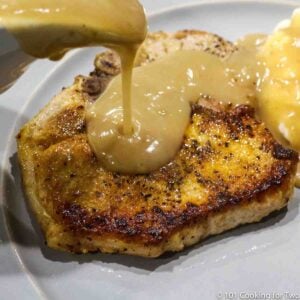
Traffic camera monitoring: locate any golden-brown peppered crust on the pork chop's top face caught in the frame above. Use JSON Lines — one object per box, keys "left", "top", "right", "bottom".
{"left": 22, "top": 106, "right": 298, "bottom": 245}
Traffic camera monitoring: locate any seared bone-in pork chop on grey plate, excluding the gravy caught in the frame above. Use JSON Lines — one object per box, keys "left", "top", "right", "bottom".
{"left": 18, "top": 31, "right": 298, "bottom": 257}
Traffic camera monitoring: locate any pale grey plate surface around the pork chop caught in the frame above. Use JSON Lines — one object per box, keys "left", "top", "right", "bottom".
{"left": 0, "top": 0, "right": 300, "bottom": 300}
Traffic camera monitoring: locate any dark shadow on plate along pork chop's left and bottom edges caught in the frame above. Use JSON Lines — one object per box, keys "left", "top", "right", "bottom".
{"left": 0, "top": 153, "right": 299, "bottom": 276}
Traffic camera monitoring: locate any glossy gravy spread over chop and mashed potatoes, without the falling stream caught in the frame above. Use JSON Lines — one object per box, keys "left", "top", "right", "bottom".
{"left": 87, "top": 14, "right": 300, "bottom": 178}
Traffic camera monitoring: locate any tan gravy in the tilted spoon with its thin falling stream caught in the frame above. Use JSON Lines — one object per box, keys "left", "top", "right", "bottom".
{"left": 0, "top": 0, "right": 147, "bottom": 134}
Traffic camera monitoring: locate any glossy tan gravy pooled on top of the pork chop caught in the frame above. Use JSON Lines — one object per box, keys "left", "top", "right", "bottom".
{"left": 87, "top": 51, "right": 260, "bottom": 174}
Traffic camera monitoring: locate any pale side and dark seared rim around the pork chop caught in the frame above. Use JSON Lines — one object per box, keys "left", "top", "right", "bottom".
{"left": 18, "top": 31, "right": 297, "bottom": 257}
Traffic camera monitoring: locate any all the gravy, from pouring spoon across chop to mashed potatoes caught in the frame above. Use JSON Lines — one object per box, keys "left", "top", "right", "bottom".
{"left": 0, "top": 0, "right": 300, "bottom": 185}
